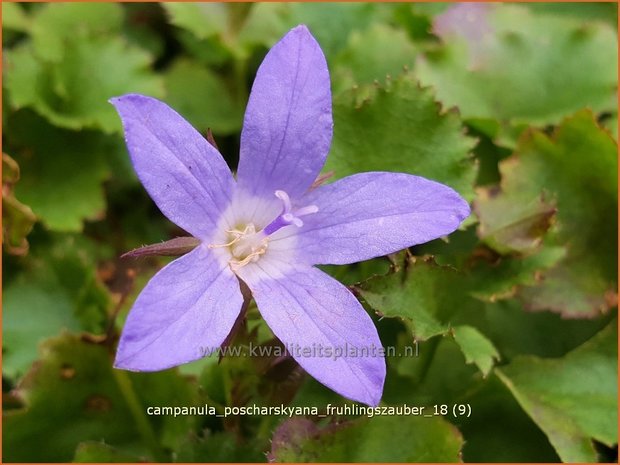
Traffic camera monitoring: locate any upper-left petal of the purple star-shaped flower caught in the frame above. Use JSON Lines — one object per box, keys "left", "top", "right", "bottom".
{"left": 110, "top": 94, "right": 235, "bottom": 239}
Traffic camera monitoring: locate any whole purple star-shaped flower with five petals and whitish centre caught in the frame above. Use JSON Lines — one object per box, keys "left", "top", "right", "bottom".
{"left": 111, "top": 26, "right": 469, "bottom": 405}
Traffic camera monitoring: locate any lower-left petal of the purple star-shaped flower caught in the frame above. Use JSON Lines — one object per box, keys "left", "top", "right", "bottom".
{"left": 114, "top": 246, "right": 243, "bottom": 371}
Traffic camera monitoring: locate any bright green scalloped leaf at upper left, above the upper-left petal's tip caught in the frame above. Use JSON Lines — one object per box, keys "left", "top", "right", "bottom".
{"left": 5, "top": 37, "right": 163, "bottom": 133}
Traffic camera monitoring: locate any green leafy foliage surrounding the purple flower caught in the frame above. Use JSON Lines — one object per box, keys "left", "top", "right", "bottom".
{"left": 2, "top": 2, "right": 617, "bottom": 462}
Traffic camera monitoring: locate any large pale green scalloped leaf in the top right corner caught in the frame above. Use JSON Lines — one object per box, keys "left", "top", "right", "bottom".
{"left": 416, "top": 5, "right": 618, "bottom": 125}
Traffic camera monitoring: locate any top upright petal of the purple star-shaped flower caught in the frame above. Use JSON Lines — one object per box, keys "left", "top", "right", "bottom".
{"left": 237, "top": 26, "right": 332, "bottom": 198}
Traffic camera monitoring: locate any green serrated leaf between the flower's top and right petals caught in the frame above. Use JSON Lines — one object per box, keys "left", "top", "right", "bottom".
{"left": 326, "top": 75, "right": 476, "bottom": 200}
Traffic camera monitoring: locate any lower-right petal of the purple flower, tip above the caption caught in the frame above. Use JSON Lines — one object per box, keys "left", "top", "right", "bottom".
{"left": 238, "top": 261, "right": 385, "bottom": 406}
